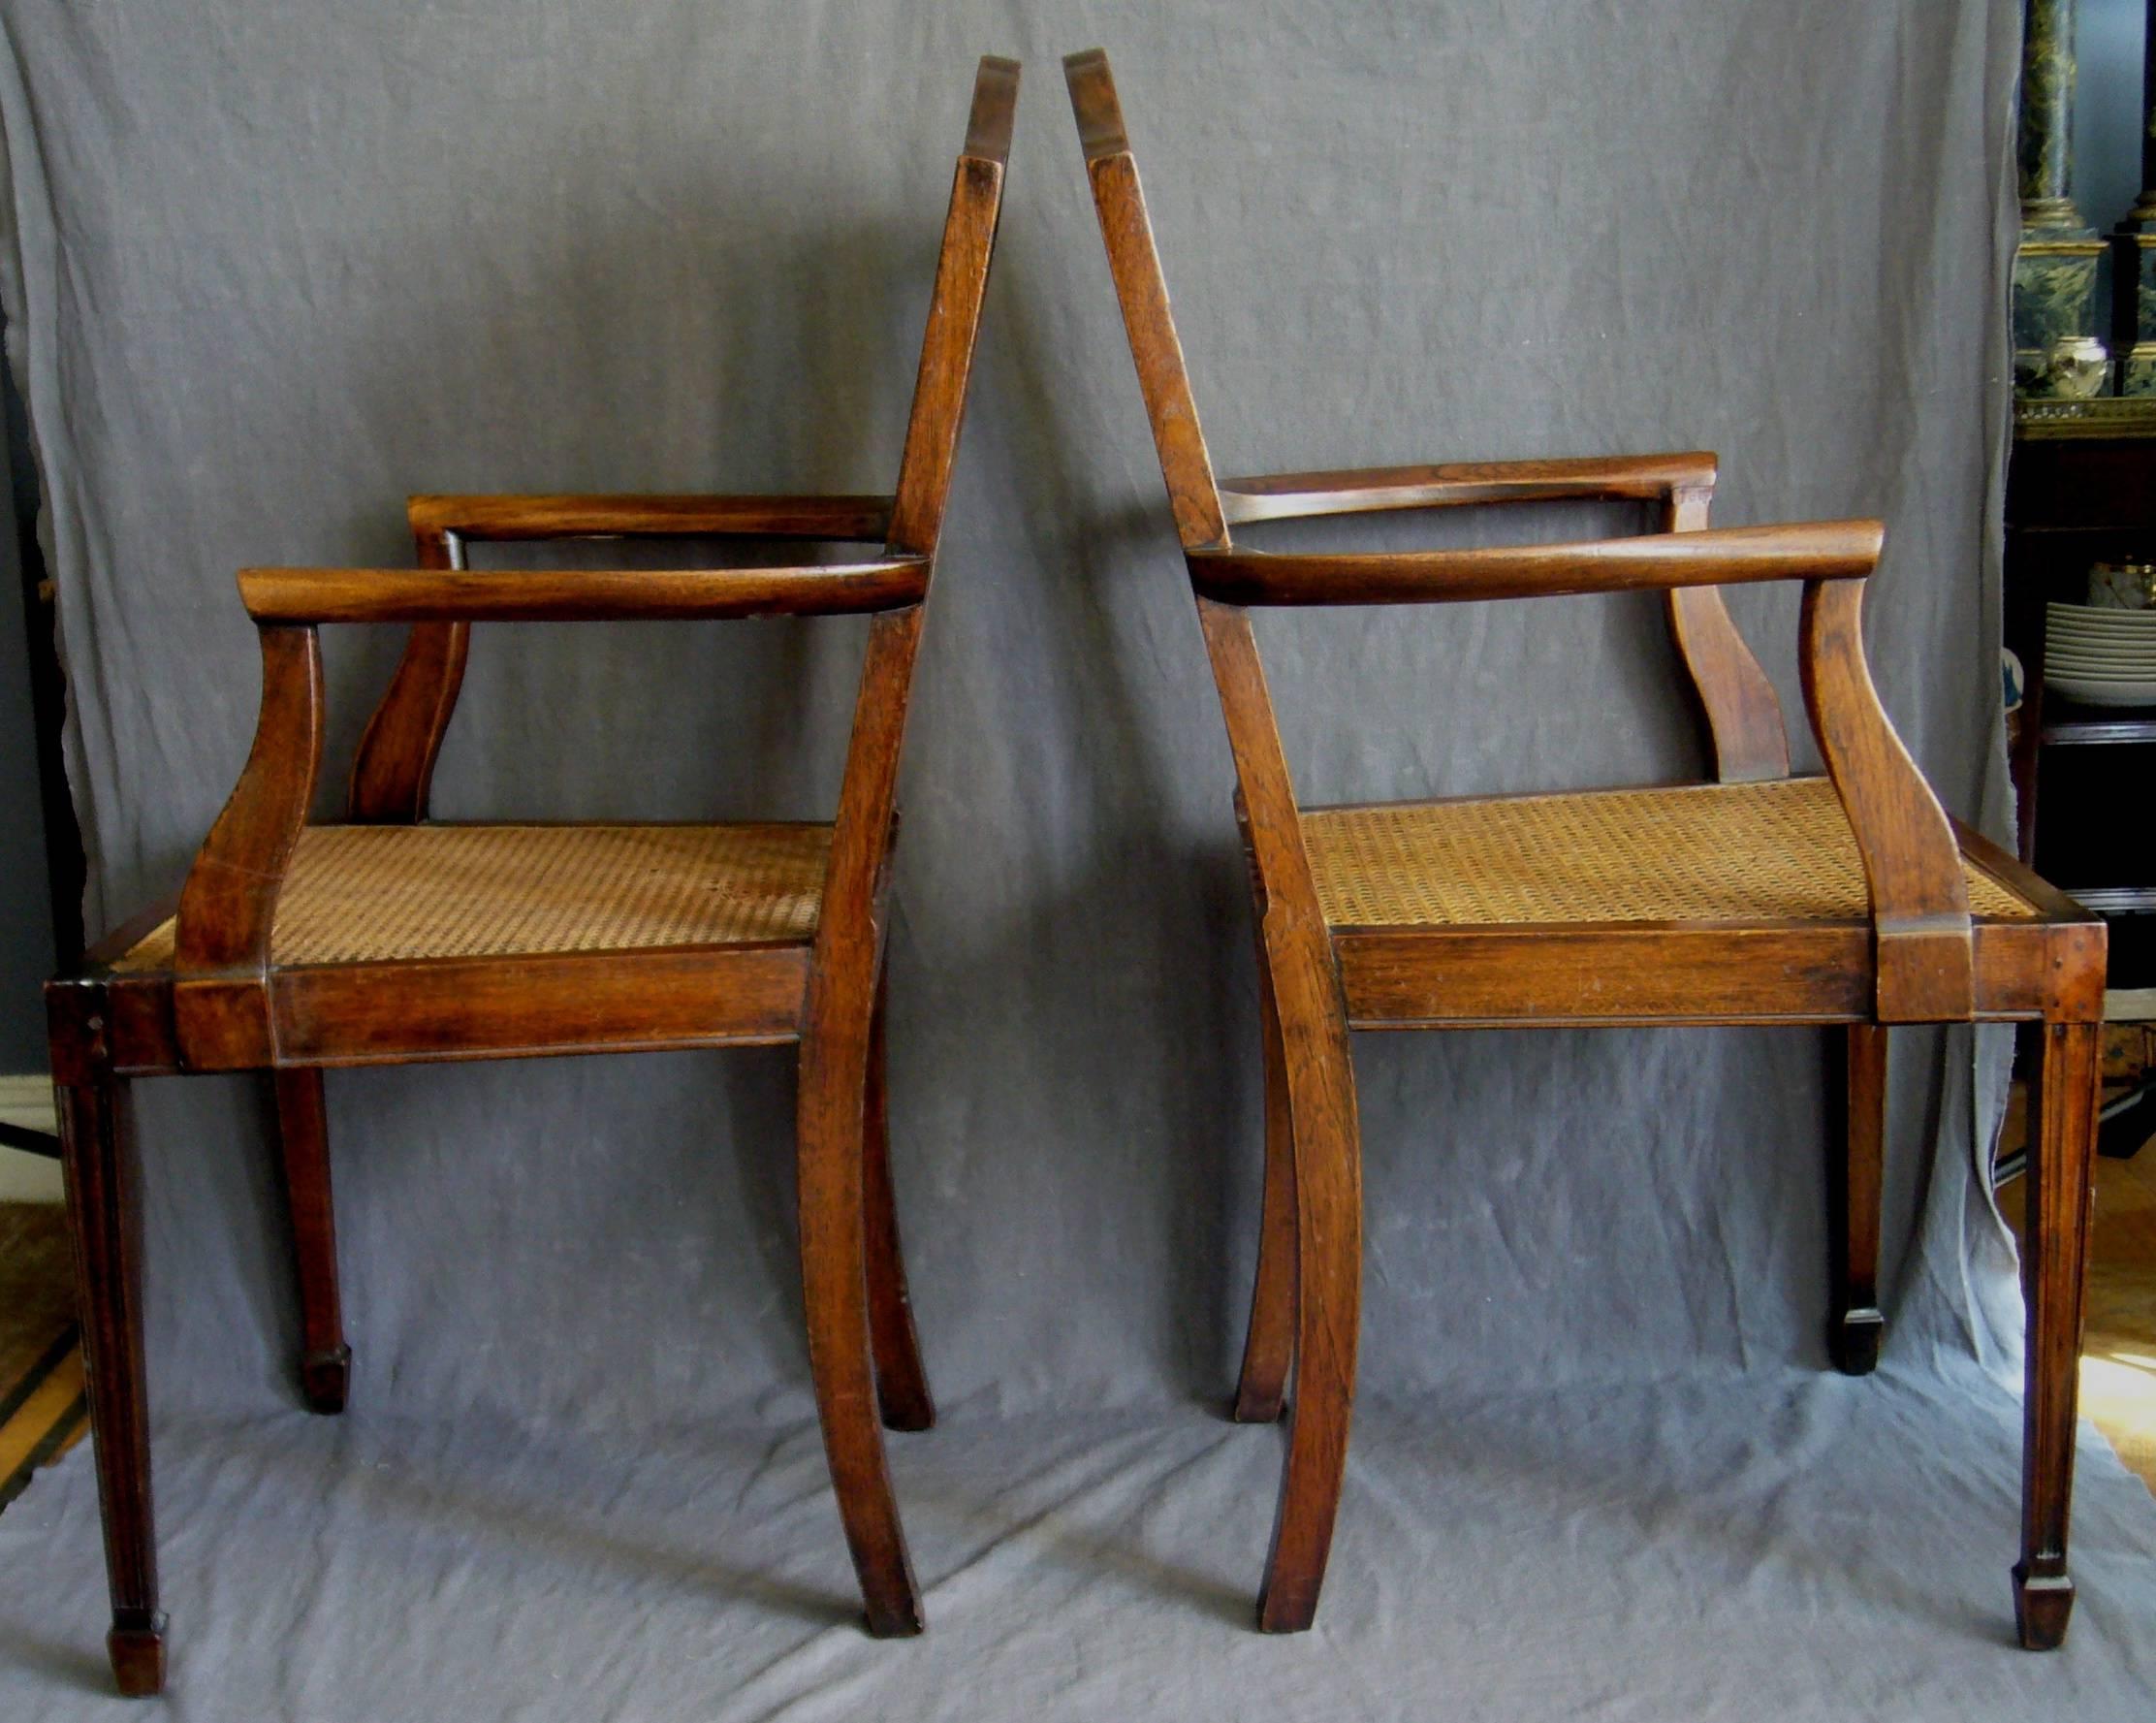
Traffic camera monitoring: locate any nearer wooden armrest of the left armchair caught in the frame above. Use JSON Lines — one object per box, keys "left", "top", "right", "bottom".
{"left": 239, "top": 557, "right": 930, "bottom": 625}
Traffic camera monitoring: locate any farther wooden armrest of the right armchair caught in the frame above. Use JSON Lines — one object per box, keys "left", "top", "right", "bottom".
{"left": 1221, "top": 453, "right": 1714, "bottom": 526}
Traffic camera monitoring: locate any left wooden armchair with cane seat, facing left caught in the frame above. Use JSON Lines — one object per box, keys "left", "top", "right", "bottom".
{"left": 48, "top": 58, "right": 1018, "bottom": 1693}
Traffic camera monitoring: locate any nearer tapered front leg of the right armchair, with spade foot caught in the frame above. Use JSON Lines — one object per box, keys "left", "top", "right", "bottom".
{"left": 2013, "top": 1022, "right": 2102, "bottom": 1652}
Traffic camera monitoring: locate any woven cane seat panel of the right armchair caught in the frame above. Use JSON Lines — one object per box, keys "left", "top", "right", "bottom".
{"left": 1302, "top": 779, "right": 2035, "bottom": 927}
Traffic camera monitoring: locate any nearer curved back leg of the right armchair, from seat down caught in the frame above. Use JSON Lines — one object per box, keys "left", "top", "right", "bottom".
{"left": 1257, "top": 925, "right": 1363, "bottom": 1633}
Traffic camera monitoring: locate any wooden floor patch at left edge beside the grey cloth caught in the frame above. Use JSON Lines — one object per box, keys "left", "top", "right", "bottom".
{"left": 0, "top": 1203, "right": 88, "bottom": 1508}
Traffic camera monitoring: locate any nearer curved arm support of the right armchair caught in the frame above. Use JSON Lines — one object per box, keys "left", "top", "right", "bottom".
{"left": 1802, "top": 580, "right": 1975, "bottom": 1022}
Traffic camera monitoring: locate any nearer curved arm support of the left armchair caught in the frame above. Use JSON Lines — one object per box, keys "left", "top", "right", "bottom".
{"left": 173, "top": 625, "right": 321, "bottom": 1068}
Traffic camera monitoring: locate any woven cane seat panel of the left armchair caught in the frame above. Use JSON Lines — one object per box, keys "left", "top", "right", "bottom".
{"left": 118, "top": 826, "right": 830, "bottom": 969}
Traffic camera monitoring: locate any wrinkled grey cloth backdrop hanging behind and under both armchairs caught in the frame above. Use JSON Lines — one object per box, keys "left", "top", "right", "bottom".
{"left": 0, "top": 0, "right": 2156, "bottom": 1723}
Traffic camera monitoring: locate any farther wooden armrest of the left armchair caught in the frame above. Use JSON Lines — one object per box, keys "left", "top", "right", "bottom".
{"left": 405, "top": 496, "right": 891, "bottom": 543}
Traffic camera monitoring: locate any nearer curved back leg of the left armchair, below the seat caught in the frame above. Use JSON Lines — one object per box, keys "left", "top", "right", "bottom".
{"left": 798, "top": 1026, "right": 921, "bottom": 1639}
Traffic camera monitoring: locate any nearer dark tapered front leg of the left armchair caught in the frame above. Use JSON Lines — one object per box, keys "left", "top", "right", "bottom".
{"left": 56, "top": 1061, "right": 164, "bottom": 1697}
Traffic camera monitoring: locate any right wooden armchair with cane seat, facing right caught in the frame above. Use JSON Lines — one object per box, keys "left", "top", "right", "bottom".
{"left": 1062, "top": 51, "right": 2105, "bottom": 1647}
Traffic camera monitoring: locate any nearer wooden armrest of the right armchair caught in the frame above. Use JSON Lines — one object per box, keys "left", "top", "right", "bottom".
{"left": 1186, "top": 520, "right": 1885, "bottom": 604}
